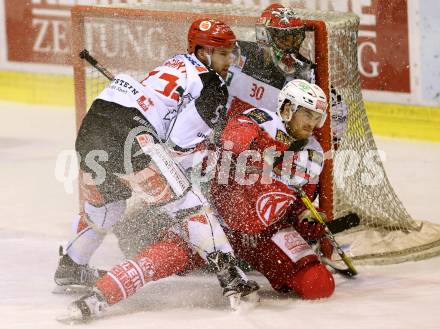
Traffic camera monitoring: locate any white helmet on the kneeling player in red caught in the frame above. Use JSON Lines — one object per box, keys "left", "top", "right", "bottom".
{"left": 277, "top": 79, "right": 328, "bottom": 128}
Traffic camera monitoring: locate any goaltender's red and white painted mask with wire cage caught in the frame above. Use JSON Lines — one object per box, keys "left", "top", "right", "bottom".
{"left": 255, "top": 3, "right": 306, "bottom": 74}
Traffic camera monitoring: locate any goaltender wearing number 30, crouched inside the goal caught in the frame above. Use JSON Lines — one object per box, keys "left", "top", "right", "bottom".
{"left": 227, "top": 3, "right": 347, "bottom": 143}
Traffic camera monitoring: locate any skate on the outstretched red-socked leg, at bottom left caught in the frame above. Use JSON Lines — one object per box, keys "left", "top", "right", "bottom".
{"left": 57, "top": 290, "right": 109, "bottom": 324}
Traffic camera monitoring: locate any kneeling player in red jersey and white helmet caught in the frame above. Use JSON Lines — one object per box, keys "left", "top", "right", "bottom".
{"left": 211, "top": 80, "right": 335, "bottom": 299}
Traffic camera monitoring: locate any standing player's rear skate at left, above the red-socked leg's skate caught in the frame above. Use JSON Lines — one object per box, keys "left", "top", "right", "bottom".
{"left": 53, "top": 247, "right": 107, "bottom": 293}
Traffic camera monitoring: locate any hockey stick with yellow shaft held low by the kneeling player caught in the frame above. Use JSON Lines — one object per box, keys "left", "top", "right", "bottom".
{"left": 293, "top": 185, "right": 357, "bottom": 277}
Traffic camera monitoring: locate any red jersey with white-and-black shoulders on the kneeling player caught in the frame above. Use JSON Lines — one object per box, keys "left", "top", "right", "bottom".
{"left": 212, "top": 109, "right": 324, "bottom": 234}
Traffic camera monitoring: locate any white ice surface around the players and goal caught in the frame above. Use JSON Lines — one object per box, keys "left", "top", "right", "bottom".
{"left": 0, "top": 103, "right": 440, "bottom": 329}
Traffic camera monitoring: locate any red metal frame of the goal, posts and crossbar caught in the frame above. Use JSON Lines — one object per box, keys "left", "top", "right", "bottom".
{"left": 71, "top": 5, "right": 333, "bottom": 219}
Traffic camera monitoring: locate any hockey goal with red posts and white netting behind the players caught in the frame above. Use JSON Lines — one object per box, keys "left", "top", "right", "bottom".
{"left": 72, "top": 1, "right": 440, "bottom": 264}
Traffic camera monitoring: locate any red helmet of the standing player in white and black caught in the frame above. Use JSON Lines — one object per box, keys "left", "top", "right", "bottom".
{"left": 188, "top": 18, "right": 237, "bottom": 54}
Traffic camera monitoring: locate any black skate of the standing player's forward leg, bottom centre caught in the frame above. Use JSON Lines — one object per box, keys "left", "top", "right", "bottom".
{"left": 207, "top": 251, "right": 260, "bottom": 309}
